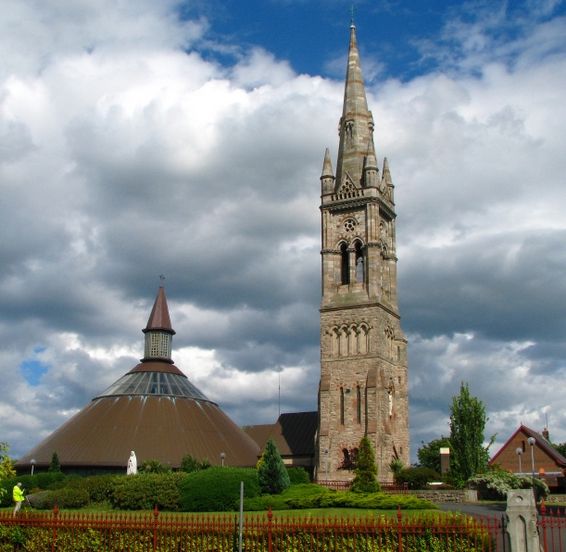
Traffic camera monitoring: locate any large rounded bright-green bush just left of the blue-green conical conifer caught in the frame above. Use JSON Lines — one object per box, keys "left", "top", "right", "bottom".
{"left": 180, "top": 467, "right": 260, "bottom": 512}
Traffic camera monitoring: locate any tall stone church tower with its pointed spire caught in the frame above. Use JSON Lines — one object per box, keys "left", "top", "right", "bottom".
{"left": 316, "top": 24, "right": 409, "bottom": 482}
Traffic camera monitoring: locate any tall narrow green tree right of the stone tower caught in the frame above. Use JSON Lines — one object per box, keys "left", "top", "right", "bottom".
{"left": 450, "top": 382, "right": 495, "bottom": 486}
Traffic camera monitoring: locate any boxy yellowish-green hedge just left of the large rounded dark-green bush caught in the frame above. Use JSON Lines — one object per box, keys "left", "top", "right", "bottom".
{"left": 110, "top": 472, "right": 186, "bottom": 510}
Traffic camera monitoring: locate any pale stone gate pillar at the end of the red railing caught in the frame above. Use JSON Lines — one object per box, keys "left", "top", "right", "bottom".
{"left": 506, "top": 489, "right": 540, "bottom": 552}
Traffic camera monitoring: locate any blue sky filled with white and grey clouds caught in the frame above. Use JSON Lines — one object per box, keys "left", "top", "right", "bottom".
{"left": 0, "top": 0, "right": 566, "bottom": 460}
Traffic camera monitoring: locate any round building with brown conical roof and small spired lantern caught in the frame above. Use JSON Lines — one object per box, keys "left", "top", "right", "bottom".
{"left": 16, "top": 287, "right": 260, "bottom": 471}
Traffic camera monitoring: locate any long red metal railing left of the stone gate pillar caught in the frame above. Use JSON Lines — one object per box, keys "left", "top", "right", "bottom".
{"left": 0, "top": 508, "right": 503, "bottom": 552}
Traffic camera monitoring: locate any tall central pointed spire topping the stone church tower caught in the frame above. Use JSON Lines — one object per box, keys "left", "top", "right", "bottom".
{"left": 336, "top": 23, "right": 375, "bottom": 190}
